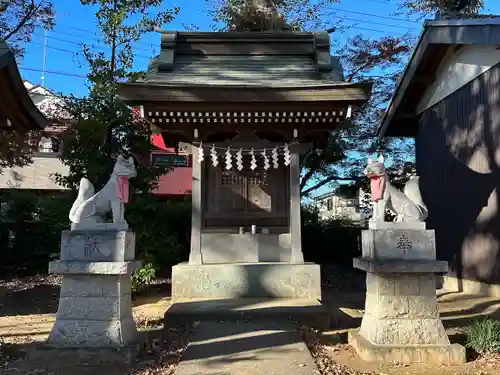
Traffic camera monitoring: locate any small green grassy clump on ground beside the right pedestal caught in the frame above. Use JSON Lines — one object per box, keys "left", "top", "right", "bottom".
{"left": 465, "top": 318, "right": 500, "bottom": 355}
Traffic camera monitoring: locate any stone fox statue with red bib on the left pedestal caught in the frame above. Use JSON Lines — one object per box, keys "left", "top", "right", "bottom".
{"left": 69, "top": 155, "right": 137, "bottom": 230}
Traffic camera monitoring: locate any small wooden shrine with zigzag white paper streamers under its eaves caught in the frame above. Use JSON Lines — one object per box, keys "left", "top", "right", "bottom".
{"left": 120, "top": 27, "right": 371, "bottom": 297}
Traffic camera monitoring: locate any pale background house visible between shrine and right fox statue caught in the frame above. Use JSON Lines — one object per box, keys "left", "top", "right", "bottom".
{"left": 314, "top": 191, "right": 363, "bottom": 224}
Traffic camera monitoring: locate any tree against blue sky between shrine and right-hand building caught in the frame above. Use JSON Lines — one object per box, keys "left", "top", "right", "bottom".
{"left": 301, "top": 35, "right": 413, "bottom": 196}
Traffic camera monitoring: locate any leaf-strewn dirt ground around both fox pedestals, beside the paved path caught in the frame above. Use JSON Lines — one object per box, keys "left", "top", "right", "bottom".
{"left": 0, "top": 267, "right": 500, "bottom": 375}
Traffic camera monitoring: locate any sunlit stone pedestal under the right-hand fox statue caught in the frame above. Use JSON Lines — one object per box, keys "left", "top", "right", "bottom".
{"left": 349, "top": 229, "right": 465, "bottom": 364}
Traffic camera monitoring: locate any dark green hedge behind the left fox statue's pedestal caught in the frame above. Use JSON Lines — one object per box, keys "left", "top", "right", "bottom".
{"left": 0, "top": 190, "right": 191, "bottom": 276}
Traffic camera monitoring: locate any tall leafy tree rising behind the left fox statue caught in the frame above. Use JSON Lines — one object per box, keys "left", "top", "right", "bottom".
{"left": 56, "top": 0, "right": 178, "bottom": 196}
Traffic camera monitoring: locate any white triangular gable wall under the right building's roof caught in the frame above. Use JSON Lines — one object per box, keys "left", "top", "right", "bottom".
{"left": 417, "top": 45, "right": 500, "bottom": 114}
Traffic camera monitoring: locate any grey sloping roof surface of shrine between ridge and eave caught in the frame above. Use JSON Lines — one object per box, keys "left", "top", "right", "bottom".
{"left": 145, "top": 55, "right": 344, "bottom": 87}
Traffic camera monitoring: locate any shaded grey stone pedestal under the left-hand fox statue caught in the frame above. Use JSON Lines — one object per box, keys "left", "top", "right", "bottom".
{"left": 47, "top": 230, "right": 140, "bottom": 348}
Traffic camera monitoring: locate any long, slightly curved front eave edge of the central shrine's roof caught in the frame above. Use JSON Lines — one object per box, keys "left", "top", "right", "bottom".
{"left": 119, "top": 82, "right": 373, "bottom": 106}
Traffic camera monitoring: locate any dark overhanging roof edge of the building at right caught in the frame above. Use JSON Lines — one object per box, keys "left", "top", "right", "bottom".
{"left": 377, "top": 15, "right": 500, "bottom": 137}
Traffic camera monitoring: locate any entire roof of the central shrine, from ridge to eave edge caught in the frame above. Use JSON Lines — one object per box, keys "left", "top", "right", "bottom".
{"left": 120, "top": 31, "right": 371, "bottom": 105}
